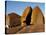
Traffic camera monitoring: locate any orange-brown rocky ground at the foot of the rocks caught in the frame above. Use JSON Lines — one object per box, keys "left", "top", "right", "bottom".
{"left": 7, "top": 24, "right": 45, "bottom": 34}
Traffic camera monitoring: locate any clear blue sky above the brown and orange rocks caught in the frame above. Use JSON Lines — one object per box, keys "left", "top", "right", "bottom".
{"left": 6, "top": 1, "right": 45, "bottom": 15}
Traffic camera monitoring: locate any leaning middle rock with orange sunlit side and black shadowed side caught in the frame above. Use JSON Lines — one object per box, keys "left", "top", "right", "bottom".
{"left": 21, "top": 7, "right": 32, "bottom": 26}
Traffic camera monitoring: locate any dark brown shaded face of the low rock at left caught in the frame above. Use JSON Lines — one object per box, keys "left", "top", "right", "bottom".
{"left": 8, "top": 13, "right": 20, "bottom": 27}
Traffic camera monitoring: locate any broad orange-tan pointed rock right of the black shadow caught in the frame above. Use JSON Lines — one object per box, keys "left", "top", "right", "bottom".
{"left": 31, "top": 7, "right": 43, "bottom": 24}
